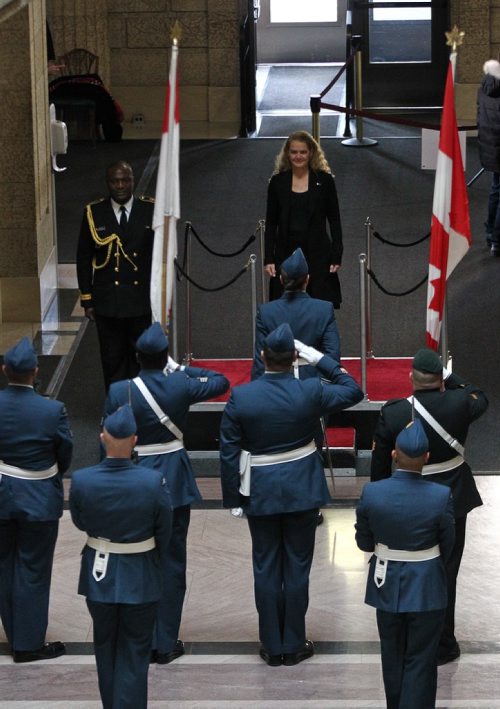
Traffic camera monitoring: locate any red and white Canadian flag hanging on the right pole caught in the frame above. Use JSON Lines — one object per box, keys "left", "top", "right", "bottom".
{"left": 426, "top": 53, "right": 471, "bottom": 350}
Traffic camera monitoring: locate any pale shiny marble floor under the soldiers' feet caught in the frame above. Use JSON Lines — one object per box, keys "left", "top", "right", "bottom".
{"left": 0, "top": 475, "right": 500, "bottom": 709}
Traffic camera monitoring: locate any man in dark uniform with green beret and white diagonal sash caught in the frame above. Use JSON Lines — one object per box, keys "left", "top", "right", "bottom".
{"left": 371, "top": 348, "right": 488, "bottom": 664}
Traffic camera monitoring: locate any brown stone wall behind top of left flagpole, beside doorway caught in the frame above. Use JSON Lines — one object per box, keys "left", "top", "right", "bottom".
{"left": 108, "top": 0, "right": 240, "bottom": 133}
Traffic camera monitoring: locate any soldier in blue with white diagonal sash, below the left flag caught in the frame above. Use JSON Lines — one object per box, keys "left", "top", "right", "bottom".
{"left": 105, "top": 323, "right": 229, "bottom": 664}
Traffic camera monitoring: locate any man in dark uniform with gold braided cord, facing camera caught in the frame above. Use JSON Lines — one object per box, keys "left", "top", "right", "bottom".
{"left": 76, "top": 161, "right": 154, "bottom": 390}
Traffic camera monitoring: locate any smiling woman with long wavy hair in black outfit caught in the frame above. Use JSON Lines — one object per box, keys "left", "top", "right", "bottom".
{"left": 264, "top": 131, "right": 343, "bottom": 308}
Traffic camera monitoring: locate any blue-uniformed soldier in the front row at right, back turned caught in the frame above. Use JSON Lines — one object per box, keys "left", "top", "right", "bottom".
{"left": 356, "top": 419, "right": 455, "bottom": 709}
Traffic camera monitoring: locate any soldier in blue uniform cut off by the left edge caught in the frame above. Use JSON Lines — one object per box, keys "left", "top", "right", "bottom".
{"left": 0, "top": 337, "right": 73, "bottom": 662}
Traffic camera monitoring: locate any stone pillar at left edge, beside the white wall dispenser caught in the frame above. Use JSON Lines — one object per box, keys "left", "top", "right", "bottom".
{"left": 0, "top": 0, "right": 57, "bottom": 322}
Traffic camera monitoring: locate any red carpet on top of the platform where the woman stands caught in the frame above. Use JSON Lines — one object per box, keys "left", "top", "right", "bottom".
{"left": 191, "top": 357, "right": 412, "bottom": 401}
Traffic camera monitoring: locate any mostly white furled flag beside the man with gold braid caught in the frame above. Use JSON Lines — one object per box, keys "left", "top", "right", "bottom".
{"left": 151, "top": 41, "right": 180, "bottom": 325}
